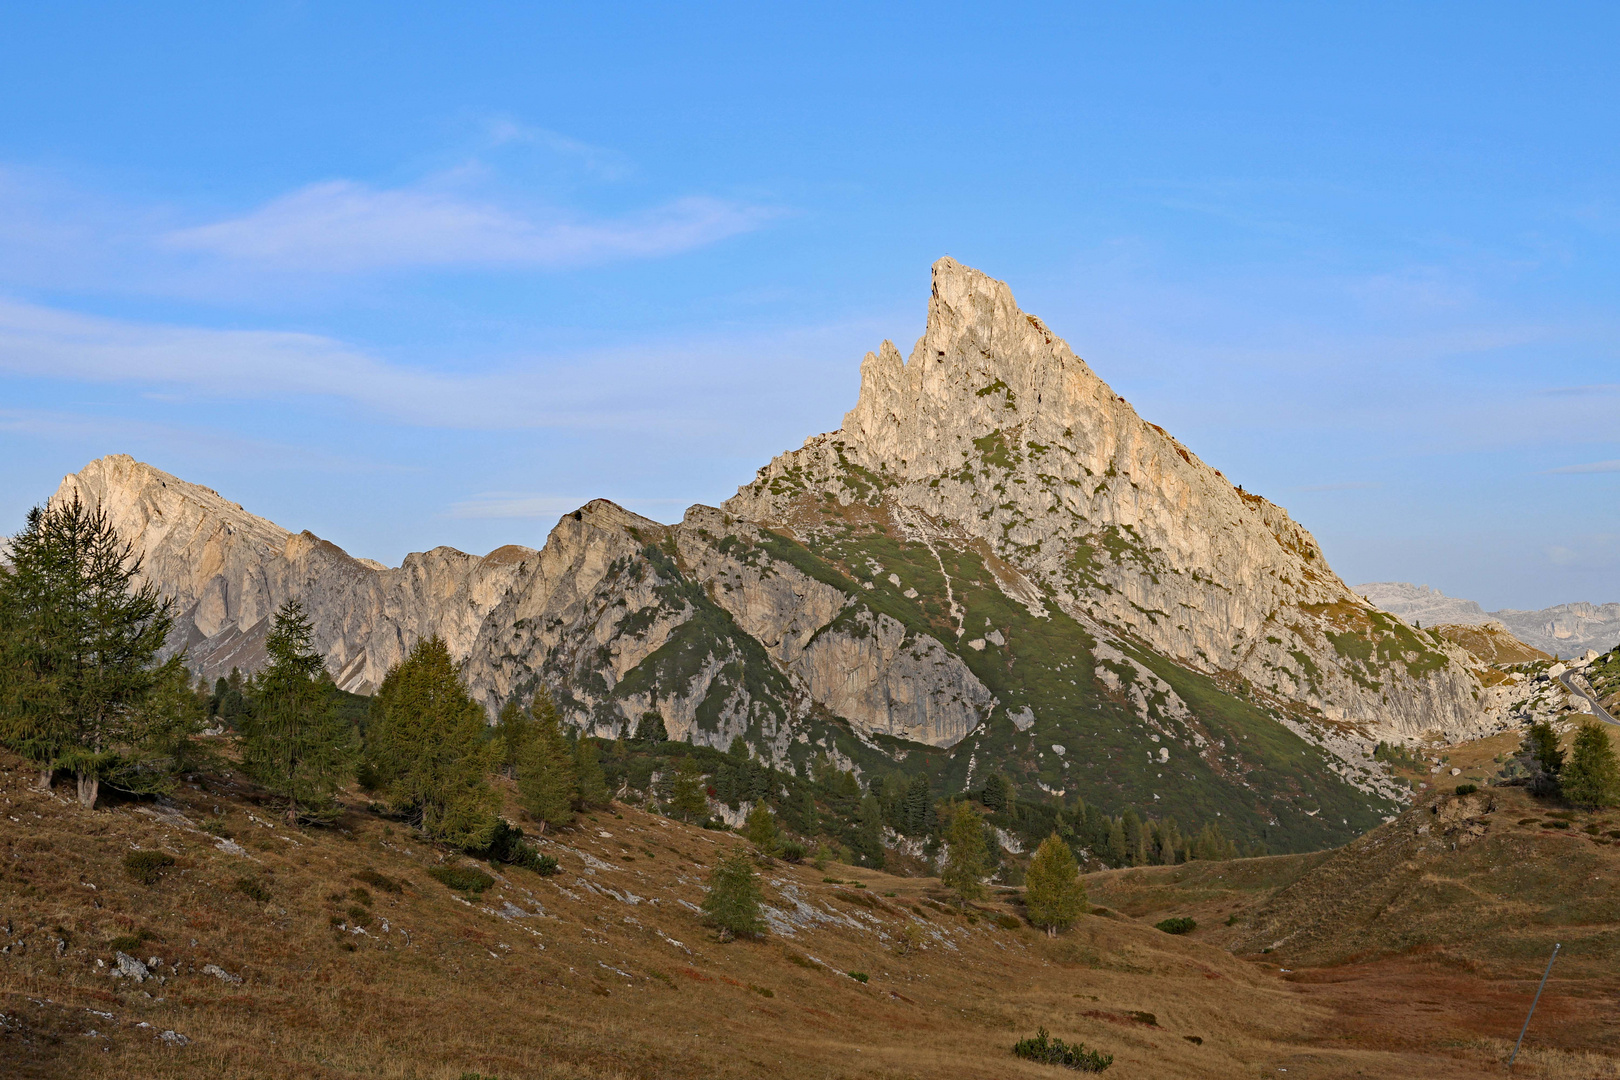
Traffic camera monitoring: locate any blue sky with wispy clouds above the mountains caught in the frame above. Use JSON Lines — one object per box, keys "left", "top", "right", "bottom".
{"left": 0, "top": 3, "right": 1620, "bottom": 609}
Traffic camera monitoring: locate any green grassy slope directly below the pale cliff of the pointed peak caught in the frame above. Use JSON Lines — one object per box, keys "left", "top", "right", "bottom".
{"left": 735, "top": 508, "right": 1398, "bottom": 850}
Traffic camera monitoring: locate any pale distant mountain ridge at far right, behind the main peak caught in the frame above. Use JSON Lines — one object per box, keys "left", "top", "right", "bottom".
{"left": 1354, "top": 581, "right": 1620, "bottom": 659}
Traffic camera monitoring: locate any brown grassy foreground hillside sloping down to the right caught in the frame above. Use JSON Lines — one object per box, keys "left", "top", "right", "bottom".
{"left": 0, "top": 758, "right": 1614, "bottom": 1080}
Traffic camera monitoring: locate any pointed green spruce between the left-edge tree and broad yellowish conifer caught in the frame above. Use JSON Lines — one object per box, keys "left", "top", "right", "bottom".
{"left": 241, "top": 601, "right": 360, "bottom": 824}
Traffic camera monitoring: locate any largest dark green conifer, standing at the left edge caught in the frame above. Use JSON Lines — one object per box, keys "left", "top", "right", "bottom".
{"left": 0, "top": 495, "right": 173, "bottom": 806}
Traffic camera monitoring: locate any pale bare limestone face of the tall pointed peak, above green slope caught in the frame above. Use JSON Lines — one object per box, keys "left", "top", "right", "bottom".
{"left": 726, "top": 259, "right": 1486, "bottom": 748}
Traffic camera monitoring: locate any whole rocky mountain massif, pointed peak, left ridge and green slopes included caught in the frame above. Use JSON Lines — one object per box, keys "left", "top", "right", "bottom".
{"left": 44, "top": 259, "right": 1495, "bottom": 847}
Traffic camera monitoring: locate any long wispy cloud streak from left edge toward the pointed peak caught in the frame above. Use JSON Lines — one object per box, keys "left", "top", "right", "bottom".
{"left": 0, "top": 298, "right": 874, "bottom": 440}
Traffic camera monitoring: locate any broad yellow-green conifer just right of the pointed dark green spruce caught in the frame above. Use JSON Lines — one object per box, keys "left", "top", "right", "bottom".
{"left": 366, "top": 636, "right": 501, "bottom": 850}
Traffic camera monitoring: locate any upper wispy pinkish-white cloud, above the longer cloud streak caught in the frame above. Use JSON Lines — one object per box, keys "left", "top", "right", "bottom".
{"left": 162, "top": 180, "right": 773, "bottom": 272}
